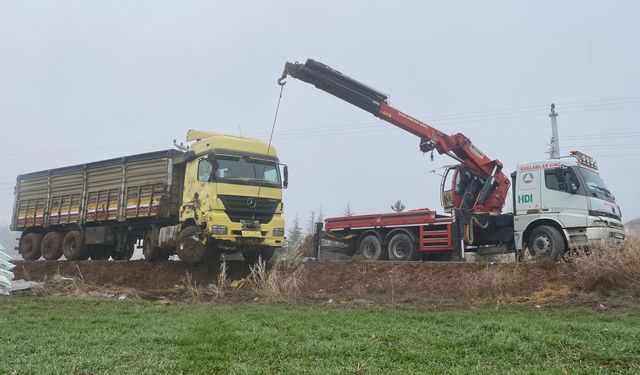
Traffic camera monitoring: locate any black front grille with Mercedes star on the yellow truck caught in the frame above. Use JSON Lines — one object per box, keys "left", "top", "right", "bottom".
{"left": 218, "top": 195, "right": 280, "bottom": 223}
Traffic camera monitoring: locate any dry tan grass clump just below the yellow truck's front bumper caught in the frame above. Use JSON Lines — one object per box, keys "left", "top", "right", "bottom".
{"left": 247, "top": 261, "right": 302, "bottom": 301}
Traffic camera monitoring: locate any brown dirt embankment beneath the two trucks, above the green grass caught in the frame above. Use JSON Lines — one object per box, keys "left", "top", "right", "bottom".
{"left": 15, "top": 260, "right": 575, "bottom": 296}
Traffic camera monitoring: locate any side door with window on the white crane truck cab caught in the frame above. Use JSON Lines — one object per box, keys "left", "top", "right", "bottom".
{"left": 541, "top": 165, "right": 589, "bottom": 228}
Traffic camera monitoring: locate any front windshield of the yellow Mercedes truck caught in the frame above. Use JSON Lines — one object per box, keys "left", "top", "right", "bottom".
{"left": 213, "top": 155, "right": 281, "bottom": 187}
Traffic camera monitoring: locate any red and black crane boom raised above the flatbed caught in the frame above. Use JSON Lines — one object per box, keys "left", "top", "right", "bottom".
{"left": 278, "top": 59, "right": 509, "bottom": 212}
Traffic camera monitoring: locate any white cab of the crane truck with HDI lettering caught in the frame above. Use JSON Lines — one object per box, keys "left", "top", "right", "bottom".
{"left": 511, "top": 151, "right": 625, "bottom": 259}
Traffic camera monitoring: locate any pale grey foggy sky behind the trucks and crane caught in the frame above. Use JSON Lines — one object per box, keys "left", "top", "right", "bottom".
{"left": 0, "top": 0, "right": 640, "bottom": 229}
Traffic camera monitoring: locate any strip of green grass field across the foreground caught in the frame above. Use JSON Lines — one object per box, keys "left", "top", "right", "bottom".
{"left": 0, "top": 297, "right": 640, "bottom": 375}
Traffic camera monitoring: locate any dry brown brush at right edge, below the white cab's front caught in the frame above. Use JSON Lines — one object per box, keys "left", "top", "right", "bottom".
{"left": 570, "top": 239, "right": 640, "bottom": 294}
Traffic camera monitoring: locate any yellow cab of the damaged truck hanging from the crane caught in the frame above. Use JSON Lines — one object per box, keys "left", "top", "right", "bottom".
{"left": 172, "top": 131, "right": 288, "bottom": 261}
